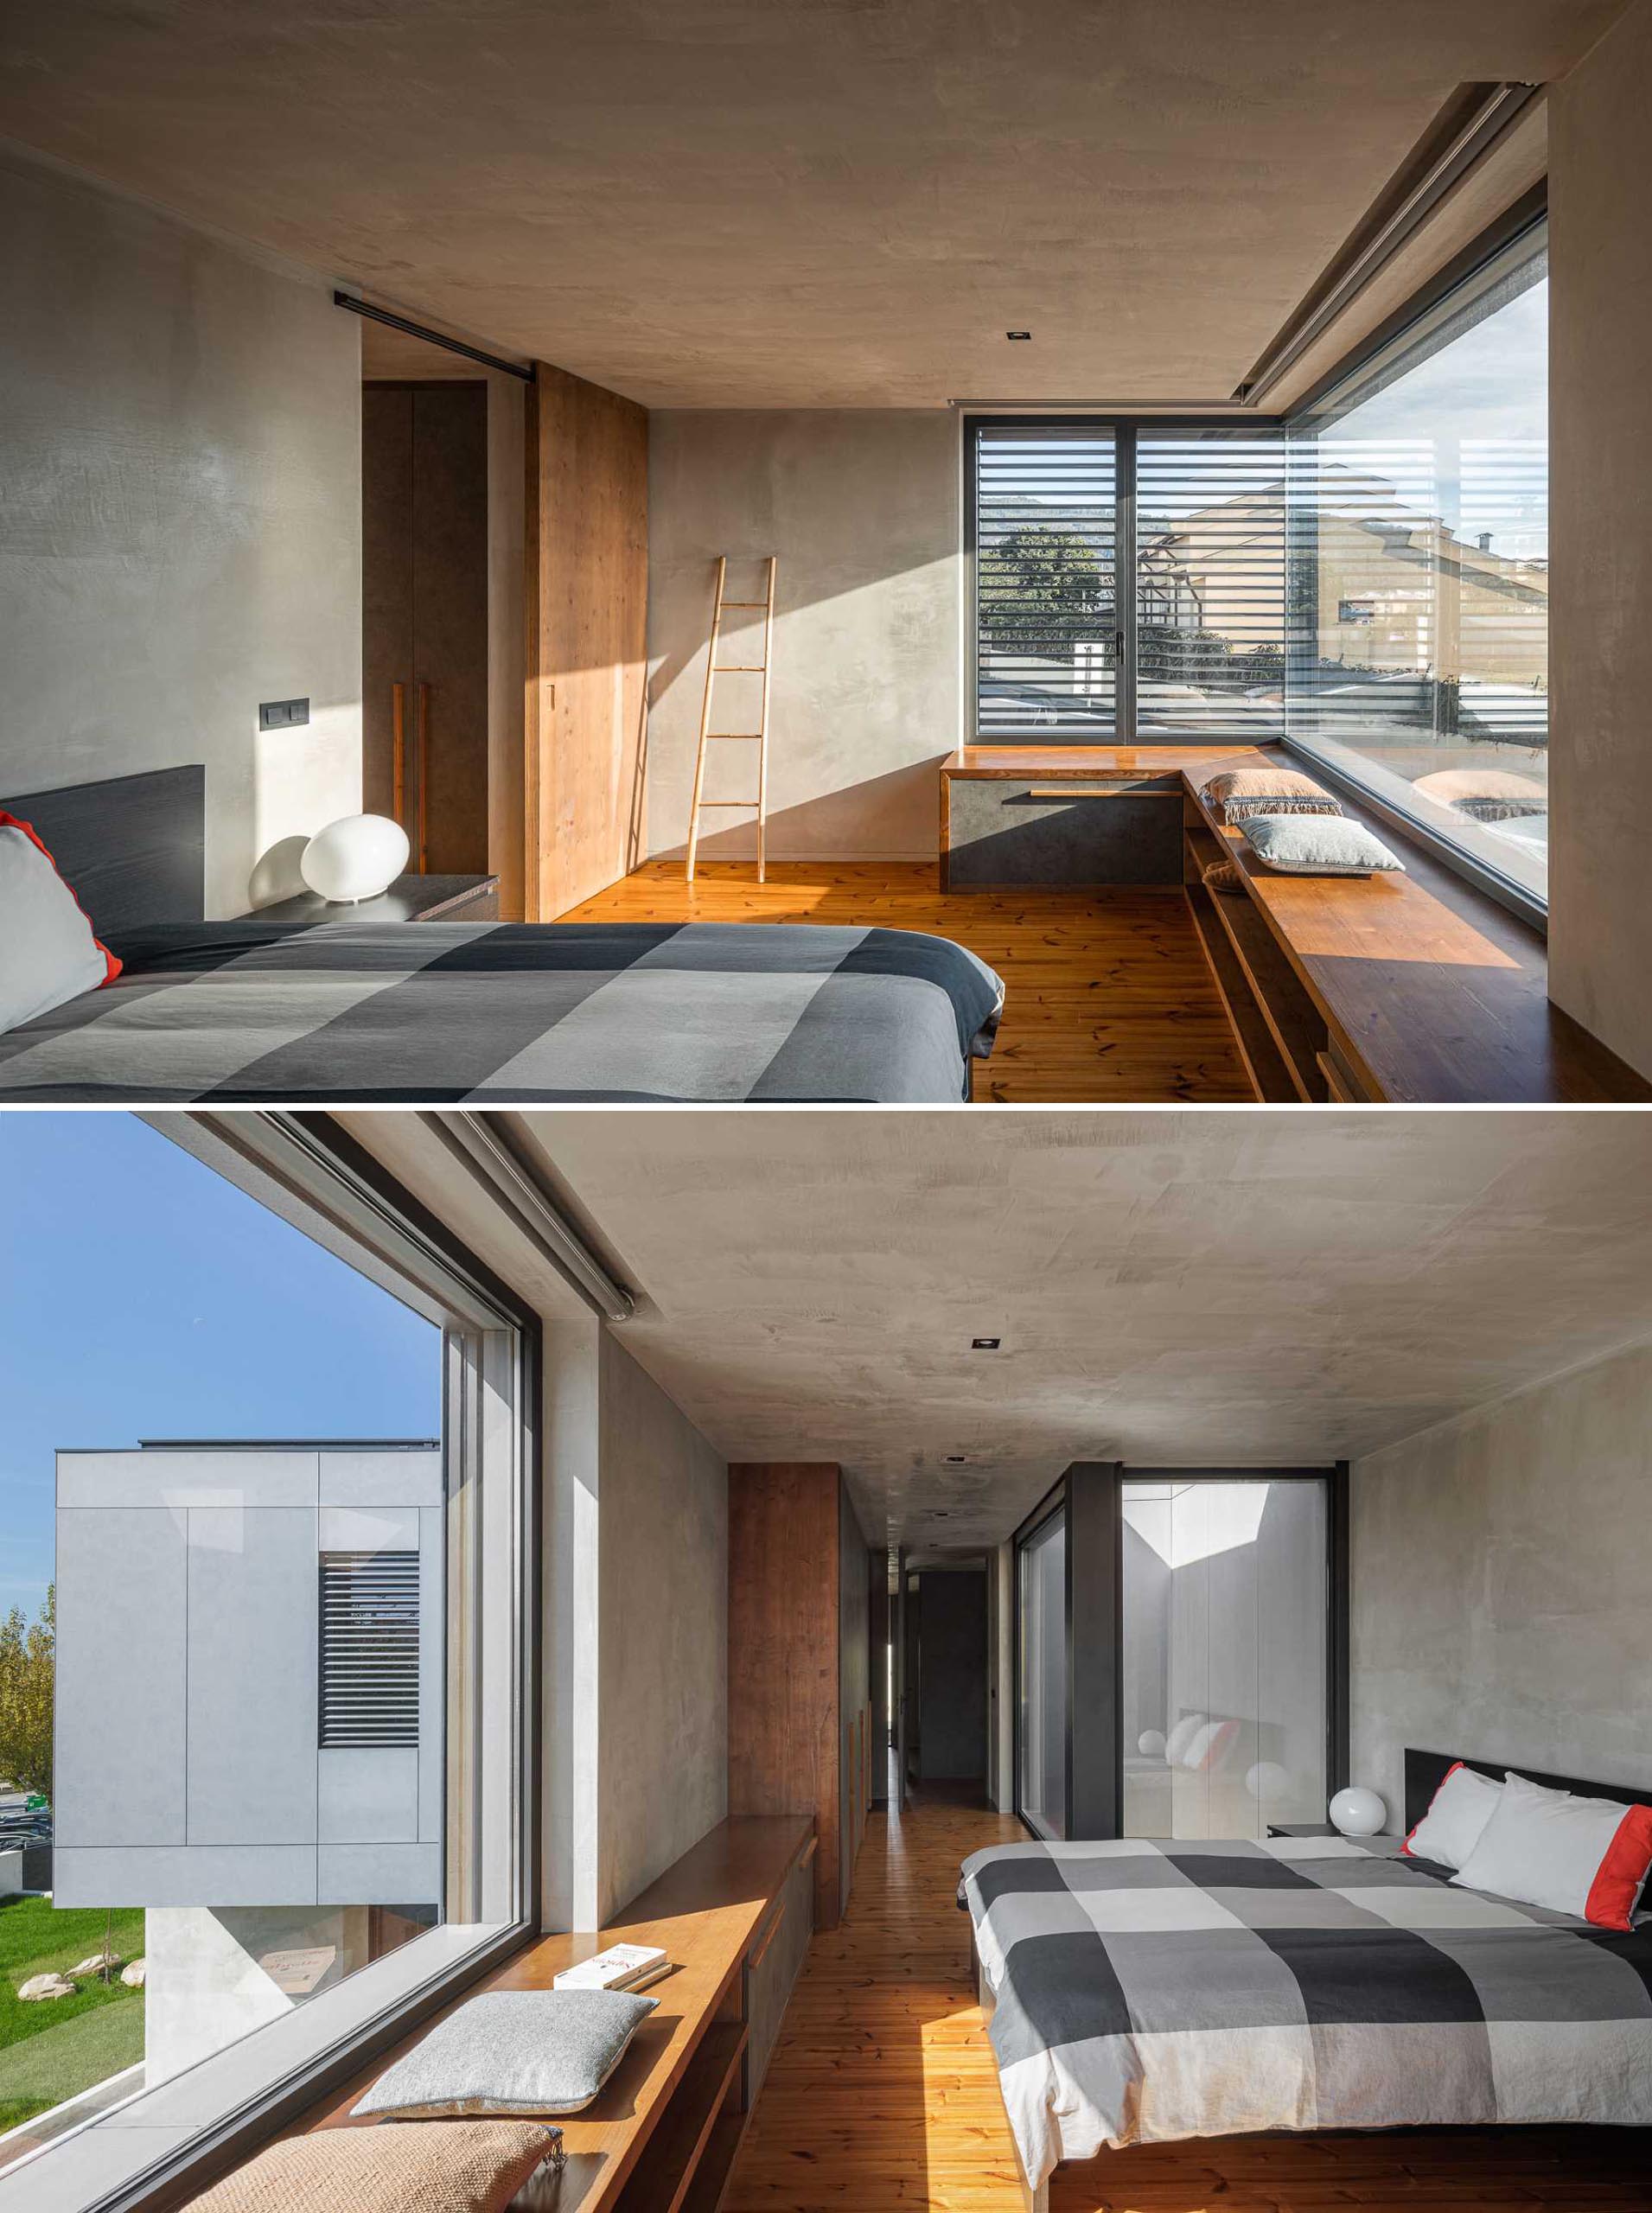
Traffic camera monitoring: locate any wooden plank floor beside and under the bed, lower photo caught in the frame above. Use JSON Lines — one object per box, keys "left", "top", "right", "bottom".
{"left": 724, "top": 1803, "right": 1652, "bottom": 2213}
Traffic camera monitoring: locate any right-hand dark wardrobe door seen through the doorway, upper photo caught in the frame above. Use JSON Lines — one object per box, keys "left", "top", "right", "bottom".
{"left": 411, "top": 383, "right": 488, "bottom": 877}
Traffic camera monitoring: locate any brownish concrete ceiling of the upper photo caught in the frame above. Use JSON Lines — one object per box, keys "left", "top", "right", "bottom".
{"left": 0, "top": 0, "right": 1621, "bottom": 407}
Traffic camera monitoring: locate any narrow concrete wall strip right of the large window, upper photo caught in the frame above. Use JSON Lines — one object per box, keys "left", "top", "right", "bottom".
{"left": 1548, "top": 9, "right": 1652, "bottom": 1075}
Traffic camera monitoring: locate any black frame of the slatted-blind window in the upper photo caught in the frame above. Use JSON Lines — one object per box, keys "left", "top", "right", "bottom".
{"left": 963, "top": 407, "right": 1286, "bottom": 752}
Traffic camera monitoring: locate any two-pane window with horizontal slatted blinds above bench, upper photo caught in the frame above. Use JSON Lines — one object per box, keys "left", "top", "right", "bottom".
{"left": 967, "top": 418, "right": 1285, "bottom": 746}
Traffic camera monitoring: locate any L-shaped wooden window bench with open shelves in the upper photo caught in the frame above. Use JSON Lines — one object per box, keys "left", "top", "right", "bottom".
{"left": 941, "top": 743, "right": 1652, "bottom": 1104}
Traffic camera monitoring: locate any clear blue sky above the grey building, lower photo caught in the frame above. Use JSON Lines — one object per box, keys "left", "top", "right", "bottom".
{"left": 0, "top": 1113, "right": 441, "bottom": 1617}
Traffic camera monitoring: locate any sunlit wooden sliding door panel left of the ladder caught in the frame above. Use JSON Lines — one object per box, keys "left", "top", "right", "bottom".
{"left": 523, "top": 360, "right": 649, "bottom": 921}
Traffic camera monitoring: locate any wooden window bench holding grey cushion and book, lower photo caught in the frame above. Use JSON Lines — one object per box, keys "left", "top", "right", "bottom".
{"left": 288, "top": 1814, "right": 815, "bottom": 2213}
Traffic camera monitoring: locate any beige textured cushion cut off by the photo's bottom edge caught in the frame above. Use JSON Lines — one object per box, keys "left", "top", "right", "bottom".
{"left": 188, "top": 2120, "right": 563, "bottom": 2213}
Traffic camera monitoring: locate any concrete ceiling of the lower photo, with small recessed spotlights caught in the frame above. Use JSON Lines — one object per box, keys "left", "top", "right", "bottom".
{"left": 523, "top": 1109, "right": 1652, "bottom": 1553}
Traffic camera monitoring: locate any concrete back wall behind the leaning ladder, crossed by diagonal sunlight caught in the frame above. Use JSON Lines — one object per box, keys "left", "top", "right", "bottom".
{"left": 647, "top": 410, "right": 961, "bottom": 861}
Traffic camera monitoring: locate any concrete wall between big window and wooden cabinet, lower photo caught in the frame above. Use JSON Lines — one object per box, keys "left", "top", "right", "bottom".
{"left": 598, "top": 1332, "right": 729, "bottom": 1914}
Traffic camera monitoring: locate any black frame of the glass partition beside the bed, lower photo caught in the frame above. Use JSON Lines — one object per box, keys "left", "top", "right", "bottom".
{"left": 1010, "top": 1461, "right": 1351, "bottom": 1843}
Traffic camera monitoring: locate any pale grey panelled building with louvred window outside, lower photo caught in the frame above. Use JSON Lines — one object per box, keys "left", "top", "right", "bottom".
{"left": 53, "top": 1441, "right": 445, "bottom": 2082}
